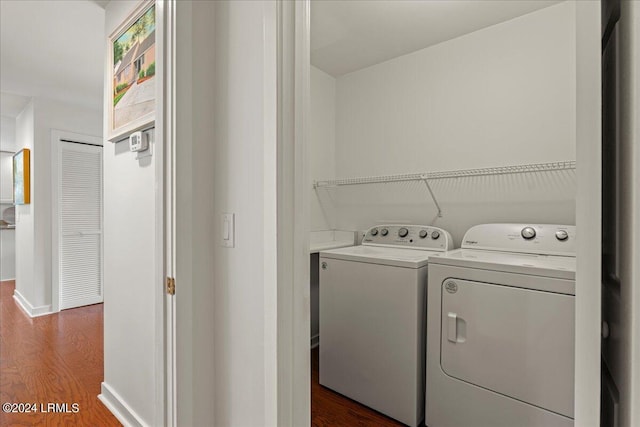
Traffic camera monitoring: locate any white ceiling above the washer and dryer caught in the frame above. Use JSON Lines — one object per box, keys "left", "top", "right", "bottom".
{"left": 311, "top": 0, "right": 560, "bottom": 77}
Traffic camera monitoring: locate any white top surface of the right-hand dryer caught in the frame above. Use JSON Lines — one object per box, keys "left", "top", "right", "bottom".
{"left": 429, "top": 249, "right": 576, "bottom": 280}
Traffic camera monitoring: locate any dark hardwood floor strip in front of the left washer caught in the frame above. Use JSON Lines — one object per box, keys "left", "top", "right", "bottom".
{"left": 311, "top": 347, "right": 404, "bottom": 427}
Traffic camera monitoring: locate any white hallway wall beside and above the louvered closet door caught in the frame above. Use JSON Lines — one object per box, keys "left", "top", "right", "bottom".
{"left": 11, "top": 98, "right": 102, "bottom": 314}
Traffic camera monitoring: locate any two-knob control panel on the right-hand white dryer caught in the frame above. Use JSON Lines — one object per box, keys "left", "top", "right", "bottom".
{"left": 462, "top": 224, "right": 576, "bottom": 256}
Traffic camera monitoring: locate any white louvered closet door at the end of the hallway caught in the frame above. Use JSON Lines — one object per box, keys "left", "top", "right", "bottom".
{"left": 58, "top": 141, "right": 103, "bottom": 310}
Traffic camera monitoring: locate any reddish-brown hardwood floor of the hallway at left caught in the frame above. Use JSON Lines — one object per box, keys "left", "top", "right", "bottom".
{"left": 0, "top": 281, "right": 121, "bottom": 427}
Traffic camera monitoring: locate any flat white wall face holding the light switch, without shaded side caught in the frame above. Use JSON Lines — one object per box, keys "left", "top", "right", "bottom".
{"left": 211, "top": 1, "right": 277, "bottom": 426}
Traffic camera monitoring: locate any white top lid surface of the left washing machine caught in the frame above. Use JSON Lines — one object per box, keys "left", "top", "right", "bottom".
{"left": 320, "top": 246, "right": 438, "bottom": 268}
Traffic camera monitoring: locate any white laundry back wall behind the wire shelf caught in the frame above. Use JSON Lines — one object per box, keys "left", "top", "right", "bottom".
{"left": 314, "top": 2, "right": 576, "bottom": 245}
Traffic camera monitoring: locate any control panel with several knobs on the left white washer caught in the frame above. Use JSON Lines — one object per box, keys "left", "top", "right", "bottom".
{"left": 362, "top": 224, "right": 453, "bottom": 251}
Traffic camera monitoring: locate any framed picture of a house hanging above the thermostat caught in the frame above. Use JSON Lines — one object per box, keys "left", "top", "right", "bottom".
{"left": 106, "top": 1, "right": 157, "bottom": 142}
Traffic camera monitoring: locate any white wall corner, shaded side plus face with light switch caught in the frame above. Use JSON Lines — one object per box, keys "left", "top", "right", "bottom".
{"left": 176, "top": 1, "right": 277, "bottom": 426}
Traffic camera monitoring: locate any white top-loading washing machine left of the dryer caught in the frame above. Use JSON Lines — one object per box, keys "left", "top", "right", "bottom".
{"left": 319, "top": 225, "right": 452, "bottom": 426}
